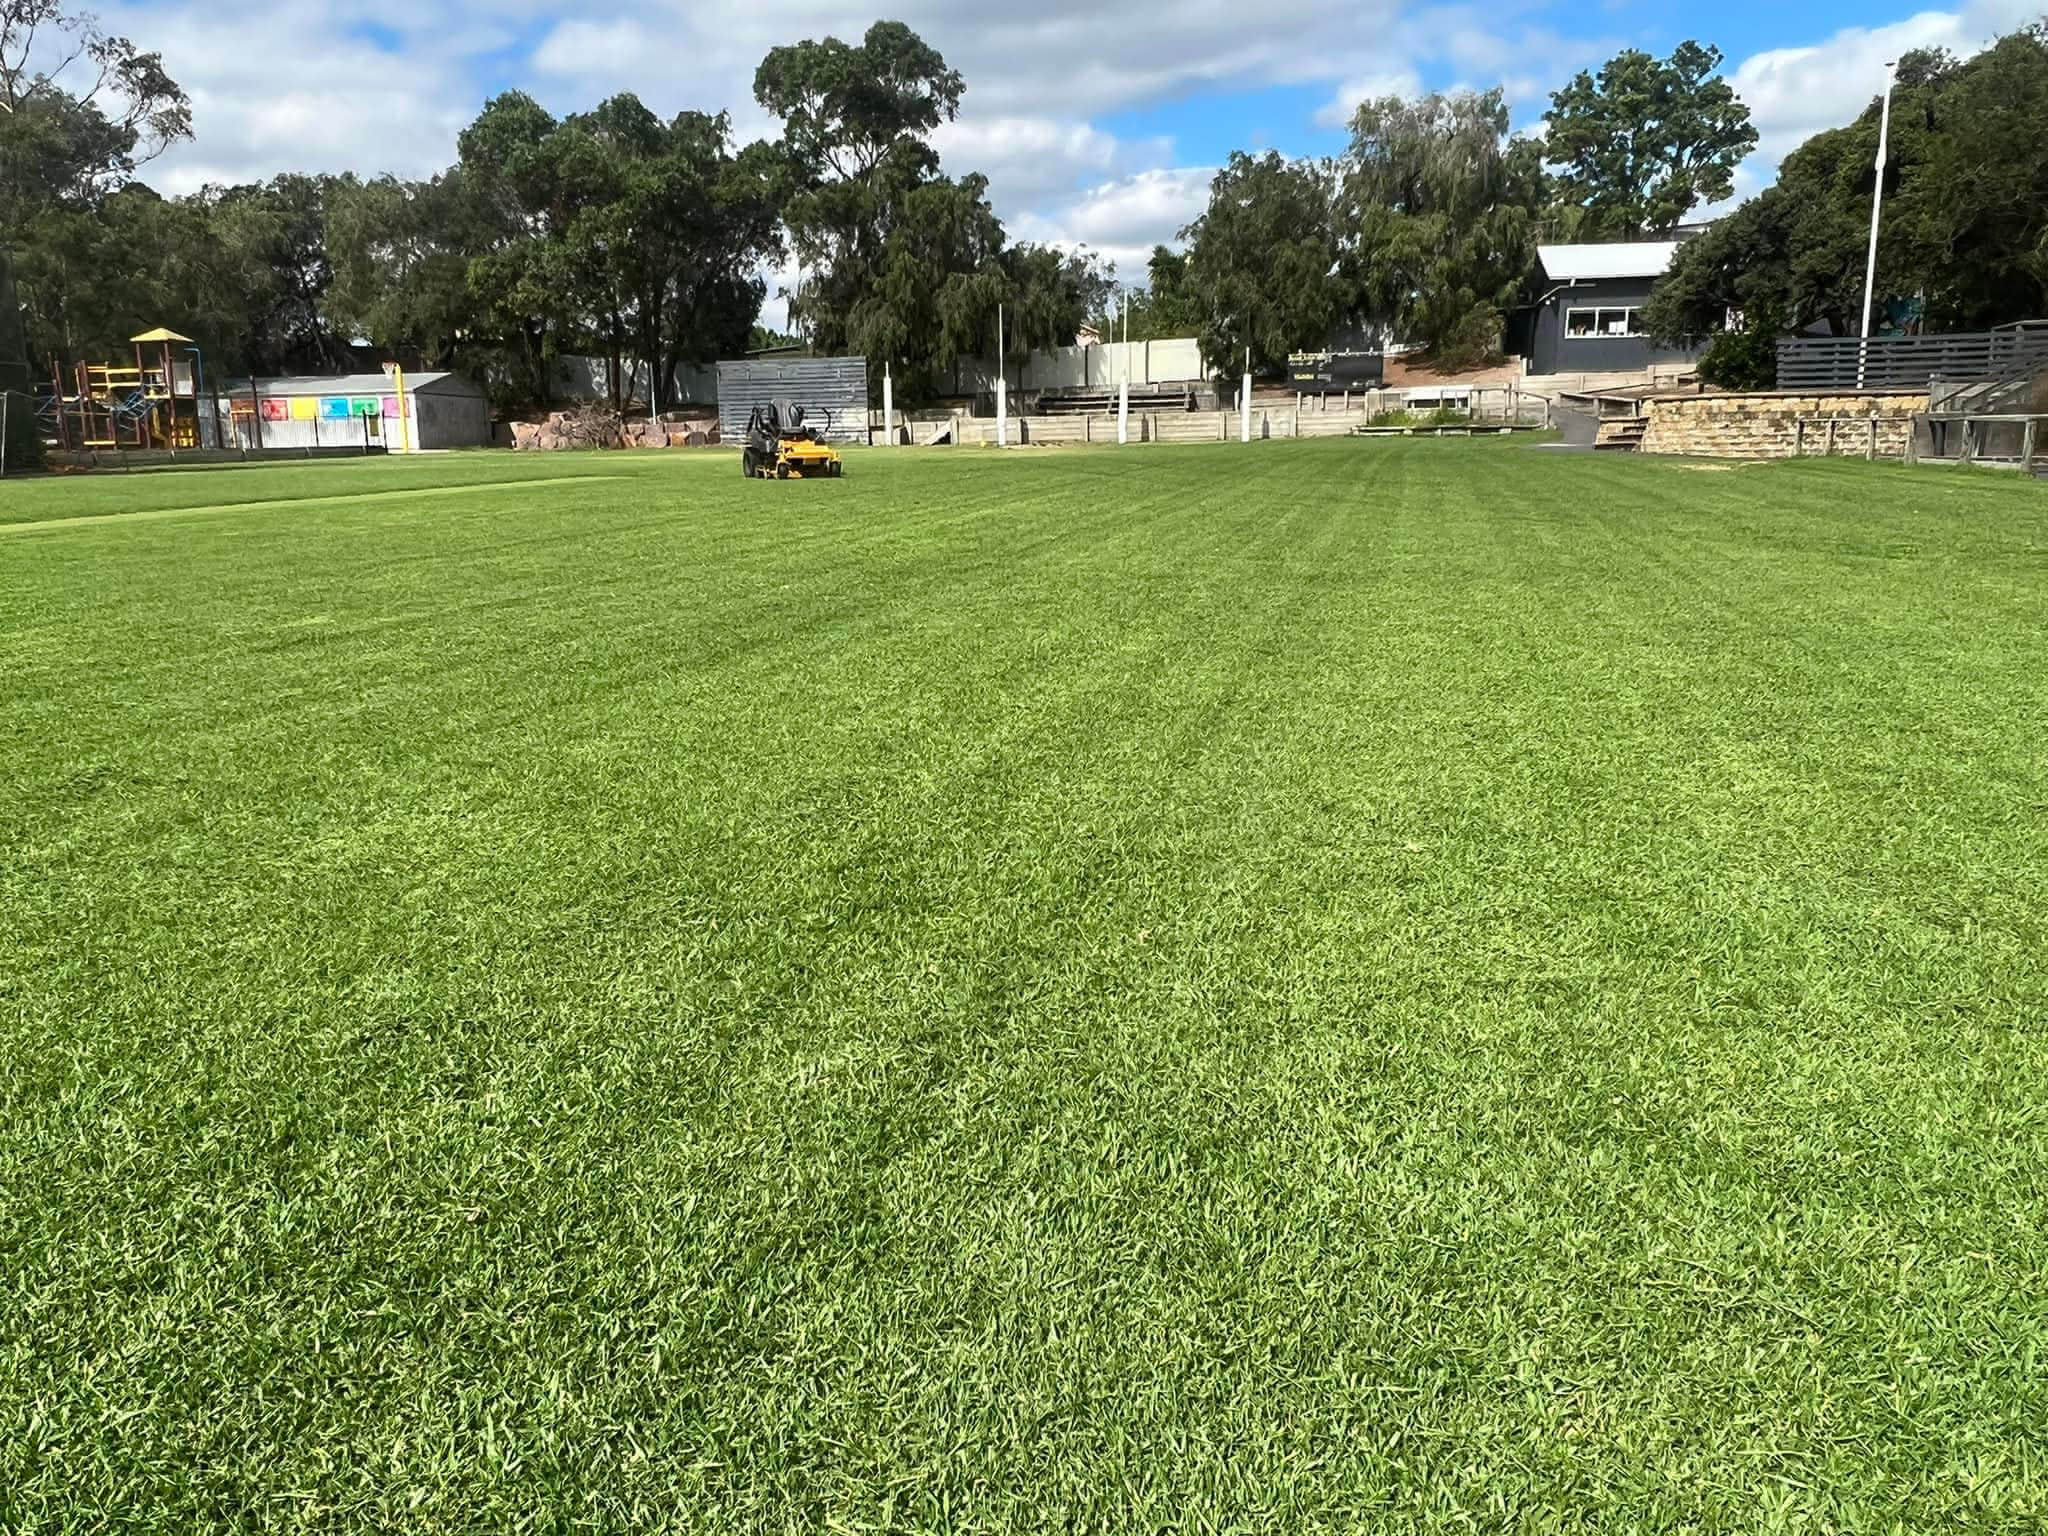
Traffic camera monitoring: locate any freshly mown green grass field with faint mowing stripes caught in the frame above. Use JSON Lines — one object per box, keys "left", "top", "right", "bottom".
{"left": 0, "top": 440, "right": 2048, "bottom": 1534}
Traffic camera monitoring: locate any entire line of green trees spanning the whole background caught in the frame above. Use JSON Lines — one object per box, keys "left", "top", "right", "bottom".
{"left": 0, "top": 0, "right": 2048, "bottom": 403}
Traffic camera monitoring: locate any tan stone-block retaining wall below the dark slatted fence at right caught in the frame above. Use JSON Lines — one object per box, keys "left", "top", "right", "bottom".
{"left": 1642, "top": 391, "right": 1927, "bottom": 459}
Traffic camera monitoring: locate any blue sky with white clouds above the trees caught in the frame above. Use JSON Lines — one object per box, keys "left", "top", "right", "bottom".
{"left": 102, "top": 0, "right": 2048, "bottom": 315}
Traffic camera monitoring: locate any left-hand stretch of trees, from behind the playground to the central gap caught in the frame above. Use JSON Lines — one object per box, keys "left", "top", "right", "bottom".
{"left": 0, "top": 10, "right": 1110, "bottom": 406}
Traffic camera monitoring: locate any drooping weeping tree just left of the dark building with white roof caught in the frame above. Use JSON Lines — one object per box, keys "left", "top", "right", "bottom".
{"left": 1337, "top": 90, "right": 1544, "bottom": 365}
